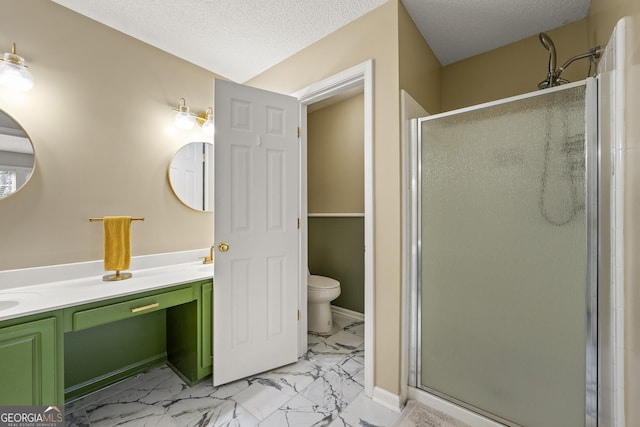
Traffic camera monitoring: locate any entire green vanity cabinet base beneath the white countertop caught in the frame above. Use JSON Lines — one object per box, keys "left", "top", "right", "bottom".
{"left": 0, "top": 279, "right": 213, "bottom": 406}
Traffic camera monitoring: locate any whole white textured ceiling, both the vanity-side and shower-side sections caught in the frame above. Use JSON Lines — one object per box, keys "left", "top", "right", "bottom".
{"left": 52, "top": 0, "right": 590, "bottom": 83}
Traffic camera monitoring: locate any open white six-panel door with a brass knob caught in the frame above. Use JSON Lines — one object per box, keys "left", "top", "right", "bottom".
{"left": 213, "top": 80, "right": 299, "bottom": 385}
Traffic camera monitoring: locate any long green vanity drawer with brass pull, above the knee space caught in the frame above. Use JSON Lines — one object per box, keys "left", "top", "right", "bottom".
{"left": 73, "top": 287, "right": 194, "bottom": 331}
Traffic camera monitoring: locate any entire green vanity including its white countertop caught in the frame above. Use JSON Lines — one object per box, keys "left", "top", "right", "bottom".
{"left": 0, "top": 254, "right": 213, "bottom": 406}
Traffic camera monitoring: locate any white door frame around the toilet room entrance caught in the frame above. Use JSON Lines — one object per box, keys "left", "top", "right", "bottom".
{"left": 291, "top": 59, "right": 375, "bottom": 397}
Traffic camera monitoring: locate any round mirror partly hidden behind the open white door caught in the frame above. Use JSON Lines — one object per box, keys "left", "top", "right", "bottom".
{"left": 168, "top": 142, "right": 213, "bottom": 212}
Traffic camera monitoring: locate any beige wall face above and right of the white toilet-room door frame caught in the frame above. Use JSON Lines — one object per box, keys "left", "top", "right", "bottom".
{"left": 247, "top": 0, "right": 408, "bottom": 393}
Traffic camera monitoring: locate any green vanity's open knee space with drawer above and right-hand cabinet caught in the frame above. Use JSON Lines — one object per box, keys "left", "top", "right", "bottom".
{"left": 64, "top": 279, "right": 213, "bottom": 399}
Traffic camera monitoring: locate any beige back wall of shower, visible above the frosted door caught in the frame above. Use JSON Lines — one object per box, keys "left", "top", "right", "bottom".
{"left": 442, "top": 19, "right": 590, "bottom": 111}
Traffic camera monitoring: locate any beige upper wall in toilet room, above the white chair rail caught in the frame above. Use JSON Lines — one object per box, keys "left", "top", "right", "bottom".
{"left": 307, "top": 94, "right": 364, "bottom": 214}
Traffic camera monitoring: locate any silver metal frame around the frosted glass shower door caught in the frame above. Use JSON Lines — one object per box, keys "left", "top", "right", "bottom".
{"left": 408, "top": 78, "right": 609, "bottom": 427}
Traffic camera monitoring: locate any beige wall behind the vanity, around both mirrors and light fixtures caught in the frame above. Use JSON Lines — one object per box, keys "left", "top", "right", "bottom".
{"left": 0, "top": 1, "right": 215, "bottom": 269}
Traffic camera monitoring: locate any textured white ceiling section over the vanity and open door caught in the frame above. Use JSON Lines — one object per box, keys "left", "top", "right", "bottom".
{"left": 53, "top": 0, "right": 387, "bottom": 83}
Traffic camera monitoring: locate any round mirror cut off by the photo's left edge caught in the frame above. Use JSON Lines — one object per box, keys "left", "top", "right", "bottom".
{"left": 0, "top": 110, "right": 35, "bottom": 200}
